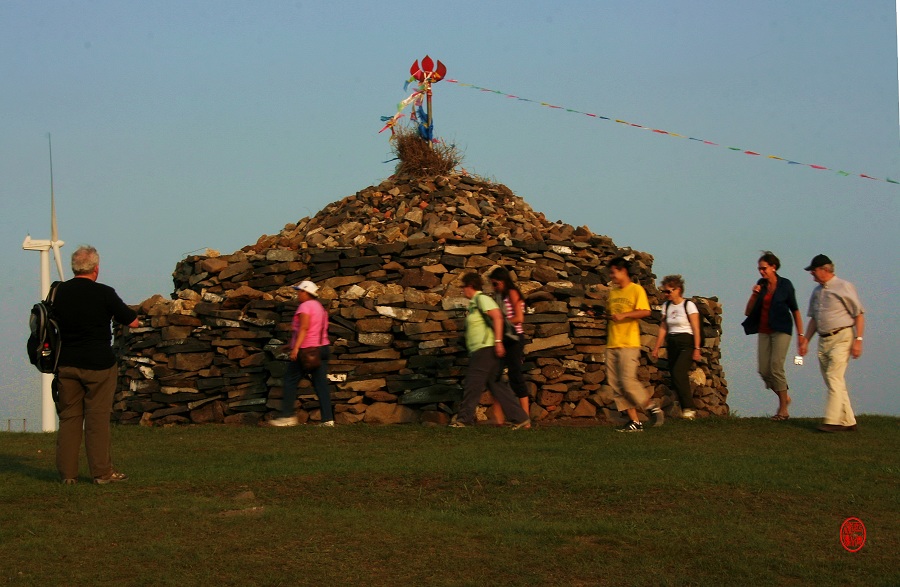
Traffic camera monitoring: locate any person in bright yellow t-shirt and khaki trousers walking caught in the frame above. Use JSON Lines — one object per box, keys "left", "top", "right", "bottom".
{"left": 606, "top": 257, "right": 665, "bottom": 432}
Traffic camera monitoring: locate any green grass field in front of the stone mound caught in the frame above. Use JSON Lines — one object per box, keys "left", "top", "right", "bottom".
{"left": 0, "top": 416, "right": 900, "bottom": 586}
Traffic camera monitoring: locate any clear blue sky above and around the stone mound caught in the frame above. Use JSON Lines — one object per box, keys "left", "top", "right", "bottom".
{"left": 0, "top": 0, "right": 900, "bottom": 430}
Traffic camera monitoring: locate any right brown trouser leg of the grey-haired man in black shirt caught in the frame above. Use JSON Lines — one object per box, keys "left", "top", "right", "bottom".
{"left": 81, "top": 365, "right": 119, "bottom": 479}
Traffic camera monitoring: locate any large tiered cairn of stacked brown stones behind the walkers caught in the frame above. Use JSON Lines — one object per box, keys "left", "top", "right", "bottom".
{"left": 113, "top": 175, "right": 728, "bottom": 425}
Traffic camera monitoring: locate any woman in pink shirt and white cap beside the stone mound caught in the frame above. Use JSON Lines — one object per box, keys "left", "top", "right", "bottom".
{"left": 269, "top": 281, "right": 334, "bottom": 426}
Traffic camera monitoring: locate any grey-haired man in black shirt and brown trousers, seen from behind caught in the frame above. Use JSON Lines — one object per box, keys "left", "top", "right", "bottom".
{"left": 53, "top": 246, "right": 138, "bottom": 485}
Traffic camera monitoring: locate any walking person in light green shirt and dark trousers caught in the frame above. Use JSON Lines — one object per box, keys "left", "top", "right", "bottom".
{"left": 451, "top": 273, "right": 531, "bottom": 430}
